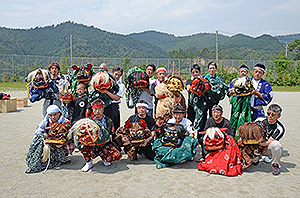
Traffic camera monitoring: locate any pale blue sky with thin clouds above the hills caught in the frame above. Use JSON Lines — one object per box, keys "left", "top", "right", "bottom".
{"left": 0, "top": 0, "right": 300, "bottom": 37}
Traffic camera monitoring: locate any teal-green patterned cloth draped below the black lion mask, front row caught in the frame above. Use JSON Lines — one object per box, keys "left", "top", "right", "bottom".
{"left": 152, "top": 136, "right": 197, "bottom": 169}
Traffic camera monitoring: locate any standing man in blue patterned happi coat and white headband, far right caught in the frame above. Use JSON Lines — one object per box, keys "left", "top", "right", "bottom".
{"left": 250, "top": 63, "right": 273, "bottom": 120}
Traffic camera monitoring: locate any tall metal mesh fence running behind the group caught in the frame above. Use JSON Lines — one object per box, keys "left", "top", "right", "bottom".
{"left": 0, "top": 54, "right": 297, "bottom": 82}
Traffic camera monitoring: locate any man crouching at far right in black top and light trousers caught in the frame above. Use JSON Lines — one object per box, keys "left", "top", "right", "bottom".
{"left": 256, "top": 104, "right": 285, "bottom": 175}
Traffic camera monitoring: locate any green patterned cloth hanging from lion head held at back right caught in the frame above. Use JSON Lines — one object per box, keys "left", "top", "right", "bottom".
{"left": 229, "top": 95, "right": 251, "bottom": 142}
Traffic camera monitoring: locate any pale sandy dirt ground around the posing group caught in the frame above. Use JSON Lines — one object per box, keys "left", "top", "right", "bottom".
{"left": 0, "top": 91, "right": 300, "bottom": 197}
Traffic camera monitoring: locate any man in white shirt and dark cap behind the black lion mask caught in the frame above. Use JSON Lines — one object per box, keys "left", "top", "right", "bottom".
{"left": 168, "top": 104, "right": 194, "bottom": 137}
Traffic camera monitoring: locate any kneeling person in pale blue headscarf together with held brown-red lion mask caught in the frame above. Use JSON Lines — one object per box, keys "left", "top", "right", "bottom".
{"left": 25, "top": 105, "right": 73, "bottom": 173}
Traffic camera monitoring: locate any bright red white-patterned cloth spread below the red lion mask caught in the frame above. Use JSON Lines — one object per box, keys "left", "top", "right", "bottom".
{"left": 198, "top": 133, "right": 242, "bottom": 177}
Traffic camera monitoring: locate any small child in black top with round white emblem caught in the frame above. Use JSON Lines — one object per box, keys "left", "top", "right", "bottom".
{"left": 72, "top": 83, "right": 89, "bottom": 123}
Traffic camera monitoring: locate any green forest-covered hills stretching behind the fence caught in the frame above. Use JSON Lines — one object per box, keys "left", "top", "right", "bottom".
{"left": 0, "top": 21, "right": 300, "bottom": 59}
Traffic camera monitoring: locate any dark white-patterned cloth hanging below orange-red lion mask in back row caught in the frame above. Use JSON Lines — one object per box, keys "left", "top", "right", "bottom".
{"left": 189, "top": 93, "right": 206, "bottom": 129}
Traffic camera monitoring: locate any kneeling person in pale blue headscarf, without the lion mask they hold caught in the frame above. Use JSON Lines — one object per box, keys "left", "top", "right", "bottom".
{"left": 25, "top": 105, "right": 73, "bottom": 173}
